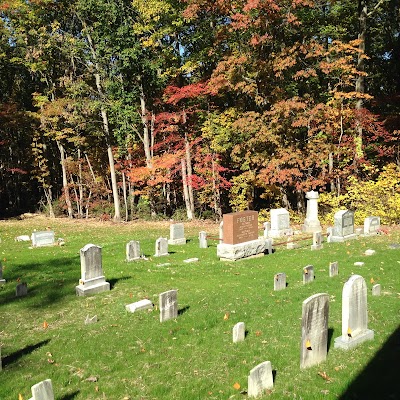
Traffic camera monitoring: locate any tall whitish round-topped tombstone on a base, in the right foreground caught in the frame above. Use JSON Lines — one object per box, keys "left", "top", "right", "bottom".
{"left": 334, "top": 275, "right": 374, "bottom": 350}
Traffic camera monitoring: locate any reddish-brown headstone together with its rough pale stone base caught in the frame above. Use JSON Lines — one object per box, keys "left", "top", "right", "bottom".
{"left": 217, "top": 211, "right": 267, "bottom": 261}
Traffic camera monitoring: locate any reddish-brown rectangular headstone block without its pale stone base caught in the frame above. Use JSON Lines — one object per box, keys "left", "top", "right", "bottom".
{"left": 223, "top": 211, "right": 258, "bottom": 244}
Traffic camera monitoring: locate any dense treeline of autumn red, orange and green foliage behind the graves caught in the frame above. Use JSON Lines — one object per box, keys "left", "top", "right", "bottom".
{"left": 0, "top": 0, "right": 400, "bottom": 220}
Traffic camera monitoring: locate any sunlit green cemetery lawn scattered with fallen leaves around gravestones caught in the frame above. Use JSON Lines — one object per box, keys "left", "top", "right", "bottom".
{"left": 0, "top": 217, "right": 400, "bottom": 400}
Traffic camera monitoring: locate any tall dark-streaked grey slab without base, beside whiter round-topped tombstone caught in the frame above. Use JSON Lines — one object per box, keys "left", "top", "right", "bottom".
{"left": 300, "top": 293, "right": 329, "bottom": 368}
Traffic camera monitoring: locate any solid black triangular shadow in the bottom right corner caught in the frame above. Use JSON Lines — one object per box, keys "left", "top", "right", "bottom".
{"left": 339, "top": 326, "right": 400, "bottom": 400}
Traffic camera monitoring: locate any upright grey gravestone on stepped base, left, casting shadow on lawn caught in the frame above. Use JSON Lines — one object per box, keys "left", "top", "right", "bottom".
{"left": 75, "top": 244, "right": 110, "bottom": 296}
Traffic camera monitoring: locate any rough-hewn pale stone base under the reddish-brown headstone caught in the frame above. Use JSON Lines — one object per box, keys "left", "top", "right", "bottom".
{"left": 217, "top": 238, "right": 267, "bottom": 261}
